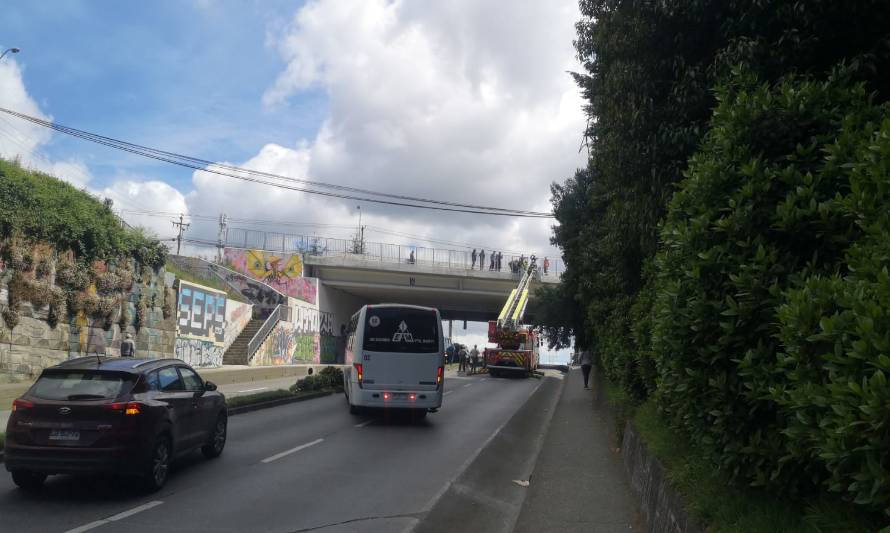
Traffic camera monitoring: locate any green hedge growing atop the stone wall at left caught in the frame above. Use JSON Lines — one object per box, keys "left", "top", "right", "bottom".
{"left": 0, "top": 159, "right": 166, "bottom": 268}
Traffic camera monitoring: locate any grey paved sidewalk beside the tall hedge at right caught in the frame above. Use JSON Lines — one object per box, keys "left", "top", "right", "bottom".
{"left": 514, "top": 368, "right": 645, "bottom": 533}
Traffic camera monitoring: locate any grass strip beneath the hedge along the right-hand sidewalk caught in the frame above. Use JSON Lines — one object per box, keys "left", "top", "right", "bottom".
{"left": 603, "top": 380, "right": 890, "bottom": 533}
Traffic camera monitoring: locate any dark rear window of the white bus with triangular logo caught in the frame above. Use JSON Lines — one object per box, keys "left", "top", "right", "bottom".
{"left": 363, "top": 307, "right": 439, "bottom": 353}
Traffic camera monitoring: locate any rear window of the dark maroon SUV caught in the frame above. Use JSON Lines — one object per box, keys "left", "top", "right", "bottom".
{"left": 31, "top": 370, "right": 135, "bottom": 400}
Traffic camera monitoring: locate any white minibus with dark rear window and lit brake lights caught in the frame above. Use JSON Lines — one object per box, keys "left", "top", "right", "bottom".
{"left": 343, "top": 304, "right": 445, "bottom": 416}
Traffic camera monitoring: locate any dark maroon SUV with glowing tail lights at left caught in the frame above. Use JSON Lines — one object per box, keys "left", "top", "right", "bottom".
{"left": 5, "top": 357, "right": 227, "bottom": 490}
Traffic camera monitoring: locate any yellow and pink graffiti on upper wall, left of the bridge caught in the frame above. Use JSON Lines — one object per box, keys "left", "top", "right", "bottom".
{"left": 225, "top": 248, "right": 318, "bottom": 304}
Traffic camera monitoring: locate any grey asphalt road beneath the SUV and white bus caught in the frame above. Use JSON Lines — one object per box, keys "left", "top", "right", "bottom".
{"left": 0, "top": 375, "right": 541, "bottom": 533}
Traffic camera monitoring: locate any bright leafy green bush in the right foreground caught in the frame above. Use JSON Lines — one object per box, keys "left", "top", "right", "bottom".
{"left": 641, "top": 71, "right": 890, "bottom": 511}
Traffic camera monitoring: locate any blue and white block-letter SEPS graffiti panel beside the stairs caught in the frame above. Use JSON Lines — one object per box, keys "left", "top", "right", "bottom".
{"left": 176, "top": 280, "right": 228, "bottom": 344}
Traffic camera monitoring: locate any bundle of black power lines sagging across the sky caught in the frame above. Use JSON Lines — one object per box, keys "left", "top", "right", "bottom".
{"left": 0, "top": 107, "right": 553, "bottom": 218}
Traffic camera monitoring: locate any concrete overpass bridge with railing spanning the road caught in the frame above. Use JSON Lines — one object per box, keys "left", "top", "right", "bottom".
{"left": 225, "top": 228, "right": 562, "bottom": 323}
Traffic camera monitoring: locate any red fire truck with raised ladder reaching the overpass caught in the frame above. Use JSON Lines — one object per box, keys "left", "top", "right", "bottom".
{"left": 484, "top": 263, "right": 538, "bottom": 378}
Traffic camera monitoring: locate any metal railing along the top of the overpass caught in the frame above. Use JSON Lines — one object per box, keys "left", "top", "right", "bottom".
{"left": 225, "top": 228, "right": 563, "bottom": 279}
